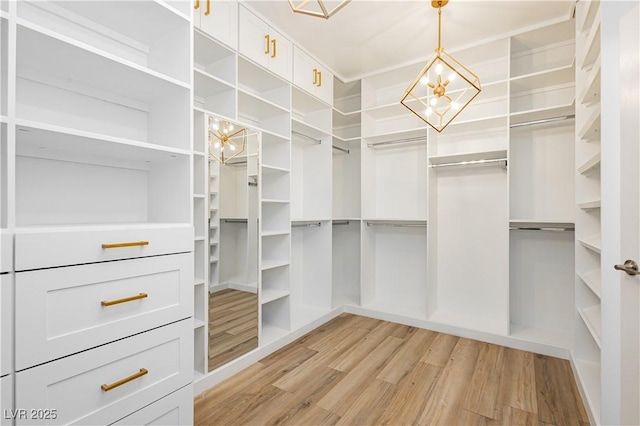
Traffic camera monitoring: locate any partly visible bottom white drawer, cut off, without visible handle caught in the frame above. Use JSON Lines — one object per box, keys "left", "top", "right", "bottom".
{"left": 113, "top": 385, "right": 193, "bottom": 426}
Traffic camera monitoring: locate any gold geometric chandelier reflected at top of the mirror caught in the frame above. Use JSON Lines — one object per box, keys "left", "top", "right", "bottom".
{"left": 207, "top": 116, "right": 247, "bottom": 164}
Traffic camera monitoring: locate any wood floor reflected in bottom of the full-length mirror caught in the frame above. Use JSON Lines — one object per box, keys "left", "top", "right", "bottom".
{"left": 209, "top": 289, "right": 258, "bottom": 371}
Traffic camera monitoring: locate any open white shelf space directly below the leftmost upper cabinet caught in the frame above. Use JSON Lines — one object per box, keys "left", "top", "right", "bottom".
{"left": 193, "top": 28, "right": 236, "bottom": 87}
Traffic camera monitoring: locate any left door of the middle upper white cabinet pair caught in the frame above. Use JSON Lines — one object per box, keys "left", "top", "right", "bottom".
{"left": 238, "top": 7, "right": 272, "bottom": 68}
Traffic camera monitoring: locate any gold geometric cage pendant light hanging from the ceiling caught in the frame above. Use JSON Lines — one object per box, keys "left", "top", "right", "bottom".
{"left": 400, "top": 0, "right": 481, "bottom": 132}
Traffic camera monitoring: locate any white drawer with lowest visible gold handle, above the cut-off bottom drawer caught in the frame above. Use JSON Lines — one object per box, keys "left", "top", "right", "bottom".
{"left": 15, "top": 319, "right": 193, "bottom": 425}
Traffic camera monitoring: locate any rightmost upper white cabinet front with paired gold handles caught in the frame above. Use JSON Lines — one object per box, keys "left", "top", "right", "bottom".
{"left": 293, "top": 46, "right": 333, "bottom": 105}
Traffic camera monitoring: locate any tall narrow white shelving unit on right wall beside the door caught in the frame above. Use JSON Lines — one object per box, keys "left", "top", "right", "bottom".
{"left": 573, "top": 1, "right": 602, "bottom": 421}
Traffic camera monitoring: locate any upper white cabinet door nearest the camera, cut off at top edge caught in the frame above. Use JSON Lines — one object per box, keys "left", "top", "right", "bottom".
{"left": 194, "top": 0, "right": 238, "bottom": 50}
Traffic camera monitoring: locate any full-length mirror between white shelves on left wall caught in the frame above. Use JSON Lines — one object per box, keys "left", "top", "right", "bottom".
{"left": 208, "top": 116, "right": 259, "bottom": 371}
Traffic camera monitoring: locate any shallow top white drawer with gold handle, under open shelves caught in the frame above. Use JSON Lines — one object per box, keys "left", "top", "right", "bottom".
{"left": 15, "top": 224, "right": 193, "bottom": 271}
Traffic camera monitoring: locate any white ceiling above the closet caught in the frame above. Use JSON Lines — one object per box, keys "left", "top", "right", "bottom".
{"left": 243, "top": 0, "right": 575, "bottom": 81}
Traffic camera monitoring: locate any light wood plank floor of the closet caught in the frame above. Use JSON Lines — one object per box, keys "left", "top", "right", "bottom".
{"left": 195, "top": 314, "right": 588, "bottom": 426}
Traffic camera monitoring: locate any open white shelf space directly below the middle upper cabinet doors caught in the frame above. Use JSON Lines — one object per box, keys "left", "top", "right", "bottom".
{"left": 238, "top": 57, "right": 291, "bottom": 111}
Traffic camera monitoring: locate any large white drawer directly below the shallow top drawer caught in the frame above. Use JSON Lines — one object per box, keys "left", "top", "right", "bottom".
{"left": 15, "top": 253, "right": 193, "bottom": 370}
